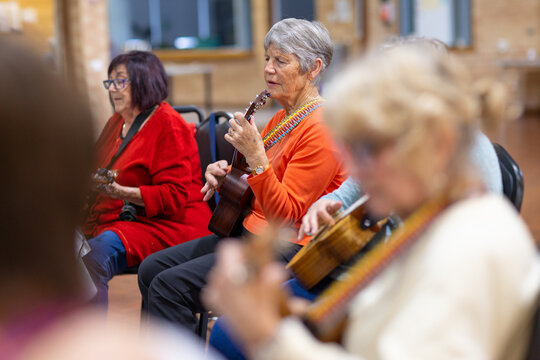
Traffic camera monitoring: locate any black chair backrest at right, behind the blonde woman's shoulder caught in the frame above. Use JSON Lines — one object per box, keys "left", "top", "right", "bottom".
{"left": 493, "top": 143, "right": 524, "bottom": 211}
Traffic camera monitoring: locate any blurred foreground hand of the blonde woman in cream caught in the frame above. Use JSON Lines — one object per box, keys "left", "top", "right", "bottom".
{"left": 202, "top": 240, "right": 286, "bottom": 352}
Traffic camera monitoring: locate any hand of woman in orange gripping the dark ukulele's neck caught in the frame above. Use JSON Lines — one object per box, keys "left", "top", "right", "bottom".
{"left": 225, "top": 112, "right": 268, "bottom": 169}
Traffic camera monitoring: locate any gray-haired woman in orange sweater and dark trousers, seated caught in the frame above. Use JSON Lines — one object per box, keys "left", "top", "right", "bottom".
{"left": 139, "top": 19, "right": 346, "bottom": 330}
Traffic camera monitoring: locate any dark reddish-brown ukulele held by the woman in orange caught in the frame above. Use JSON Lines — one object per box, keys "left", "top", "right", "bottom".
{"left": 208, "top": 90, "right": 270, "bottom": 237}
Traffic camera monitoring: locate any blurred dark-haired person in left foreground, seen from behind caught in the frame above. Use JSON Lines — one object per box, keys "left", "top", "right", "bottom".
{"left": 0, "top": 35, "right": 217, "bottom": 360}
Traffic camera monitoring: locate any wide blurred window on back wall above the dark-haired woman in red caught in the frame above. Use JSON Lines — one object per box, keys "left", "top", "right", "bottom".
{"left": 108, "top": 0, "right": 255, "bottom": 54}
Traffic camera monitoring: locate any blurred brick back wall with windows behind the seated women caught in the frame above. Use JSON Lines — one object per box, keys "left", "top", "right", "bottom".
{"left": 0, "top": 0, "right": 540, "bottom": 128}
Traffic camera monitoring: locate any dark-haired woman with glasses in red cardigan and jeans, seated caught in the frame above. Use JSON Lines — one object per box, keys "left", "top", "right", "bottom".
{"left": 83, "top": 51, "right": 211, "bottom": 304}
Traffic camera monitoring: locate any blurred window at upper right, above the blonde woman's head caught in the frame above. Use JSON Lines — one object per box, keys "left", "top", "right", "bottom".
{"left": 399, "top": 0, "right": 471, "bottom": 47}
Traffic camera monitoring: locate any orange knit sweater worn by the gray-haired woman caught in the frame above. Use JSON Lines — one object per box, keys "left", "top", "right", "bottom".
{"left": 244, "top": 107, "right": 347, "bottom": 245}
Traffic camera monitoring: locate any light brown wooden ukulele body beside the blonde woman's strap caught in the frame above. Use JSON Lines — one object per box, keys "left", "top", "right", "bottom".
{"left": 287, "top": 195, "right": 384, "bottom": 289}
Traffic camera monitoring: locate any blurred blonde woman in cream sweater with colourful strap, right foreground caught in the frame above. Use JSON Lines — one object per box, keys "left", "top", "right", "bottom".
{"left": 204, "top": 46, "right": 540, "bottom": 359}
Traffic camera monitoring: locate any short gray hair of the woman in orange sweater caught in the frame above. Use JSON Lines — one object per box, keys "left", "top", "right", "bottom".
{"left": 264, "top": 18, "right": 334, "bottom": 84}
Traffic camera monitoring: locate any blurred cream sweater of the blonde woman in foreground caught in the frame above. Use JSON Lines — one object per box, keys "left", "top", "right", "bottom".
{"left": 257, "top": 195, "right": 540, "bottom": 360}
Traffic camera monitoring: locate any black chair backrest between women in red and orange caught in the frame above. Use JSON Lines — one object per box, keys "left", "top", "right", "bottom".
{"left": 195, "top": 111, "right": 234, "bottom": 211}
